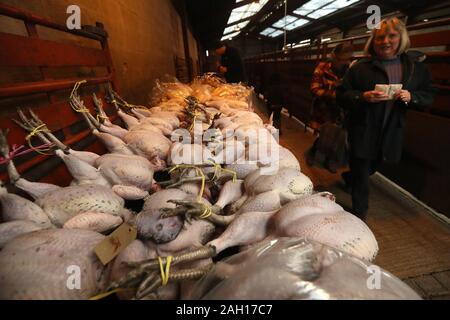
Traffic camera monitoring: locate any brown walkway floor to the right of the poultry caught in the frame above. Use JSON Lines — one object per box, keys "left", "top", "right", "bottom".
{"left": 268, "top": 109, "right": 450, "bottom": 299}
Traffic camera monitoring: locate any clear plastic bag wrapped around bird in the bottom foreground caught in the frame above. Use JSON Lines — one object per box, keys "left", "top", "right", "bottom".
{"left": 187, "top": 238, "right": 421, "bottom": 300}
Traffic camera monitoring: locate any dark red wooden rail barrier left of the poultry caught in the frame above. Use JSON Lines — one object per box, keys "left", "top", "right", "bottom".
{"left": 0, "top": 4, "right": 119, "bottom": 186}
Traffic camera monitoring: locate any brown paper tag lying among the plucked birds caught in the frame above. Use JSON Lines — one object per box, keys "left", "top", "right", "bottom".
{"left": 94, "top": 223, "right": 137, "bottom": 265}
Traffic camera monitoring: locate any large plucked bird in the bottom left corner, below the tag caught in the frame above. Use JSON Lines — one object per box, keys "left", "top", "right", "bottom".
{"left": 0, "top": 229, "right": 109, "bottom": 300}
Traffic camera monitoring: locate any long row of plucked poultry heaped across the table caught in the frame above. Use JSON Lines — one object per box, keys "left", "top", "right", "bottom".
{"left": 0, "top": 75, "right": 416, "bottom": 299}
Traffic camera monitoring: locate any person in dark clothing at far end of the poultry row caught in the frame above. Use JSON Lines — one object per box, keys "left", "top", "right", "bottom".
{"left": 215, "top": 42, "right": 247, "bottom": 83}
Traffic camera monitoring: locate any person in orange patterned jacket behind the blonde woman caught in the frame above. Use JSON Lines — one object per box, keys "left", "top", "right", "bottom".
{"left": 309, "top": 43, "right": 353, "bottom": 132}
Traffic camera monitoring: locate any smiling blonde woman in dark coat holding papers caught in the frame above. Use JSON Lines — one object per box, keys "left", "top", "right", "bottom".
{"left": 337, "top": 18, "right": 435, "bottom": 219}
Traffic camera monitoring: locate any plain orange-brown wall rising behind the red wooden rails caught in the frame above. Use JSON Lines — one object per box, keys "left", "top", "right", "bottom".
{"left": 0, "top": 0, "right": 199, "bottom": 104}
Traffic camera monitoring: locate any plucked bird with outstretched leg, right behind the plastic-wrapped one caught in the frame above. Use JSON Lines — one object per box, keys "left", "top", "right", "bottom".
{"left": 114, "top": 188, "right": 378, "bottom": 298}
